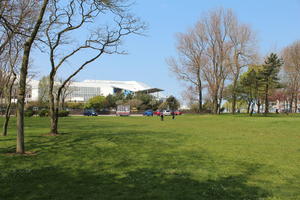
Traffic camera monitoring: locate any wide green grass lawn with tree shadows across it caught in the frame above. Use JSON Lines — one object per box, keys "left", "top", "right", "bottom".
{"left": 0, "top": 115, "right": 300, "bottom": 200}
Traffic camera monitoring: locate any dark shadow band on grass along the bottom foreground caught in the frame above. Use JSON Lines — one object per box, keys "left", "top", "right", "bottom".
{"left": 0, "top": 167, "right": 271, "bottom": 200}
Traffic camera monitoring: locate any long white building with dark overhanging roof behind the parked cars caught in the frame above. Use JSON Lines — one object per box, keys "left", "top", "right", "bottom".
{"left": 27, "top": 80, "right": 163, "bottom": 102}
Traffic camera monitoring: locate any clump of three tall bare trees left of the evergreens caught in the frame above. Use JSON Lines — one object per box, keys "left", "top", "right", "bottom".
{"left": 167, "top": 9, "right": 257, "bottom": 113}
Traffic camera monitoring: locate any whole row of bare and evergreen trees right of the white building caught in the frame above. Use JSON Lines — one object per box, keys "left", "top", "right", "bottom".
{"left": 167, "top": 8, "right": 300, "bottom": 114}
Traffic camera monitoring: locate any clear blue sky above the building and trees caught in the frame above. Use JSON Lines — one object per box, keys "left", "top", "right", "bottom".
{"left": 33, "top": 0, "right": 300, "bottom": 101}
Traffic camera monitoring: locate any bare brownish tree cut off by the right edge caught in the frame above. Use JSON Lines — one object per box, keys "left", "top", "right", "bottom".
{"left": 282, "top": 41, "right": 300, "bottom": 112}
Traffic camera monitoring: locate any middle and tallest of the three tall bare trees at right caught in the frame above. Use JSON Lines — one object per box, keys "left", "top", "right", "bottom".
{"left": 201, "top": 9, "right": 234, "bottom": 114}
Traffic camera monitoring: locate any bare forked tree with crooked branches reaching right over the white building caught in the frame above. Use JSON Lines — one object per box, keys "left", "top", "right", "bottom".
{"left": 45, "top": 0, "right": 145, "bottom": 135}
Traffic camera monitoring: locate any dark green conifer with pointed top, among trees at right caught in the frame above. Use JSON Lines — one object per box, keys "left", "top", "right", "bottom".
{"left": 260, "top": 53, "right": 283, "bottom": 115}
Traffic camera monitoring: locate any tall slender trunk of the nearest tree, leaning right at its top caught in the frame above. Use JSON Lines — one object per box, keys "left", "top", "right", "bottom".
{"left": 16, "top": 0, "right": 48, "bottom": 154}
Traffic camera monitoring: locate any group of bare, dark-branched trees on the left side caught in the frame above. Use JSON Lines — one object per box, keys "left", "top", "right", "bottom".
{"left": 0, "top": 0, "right": 145, "bottom": 153}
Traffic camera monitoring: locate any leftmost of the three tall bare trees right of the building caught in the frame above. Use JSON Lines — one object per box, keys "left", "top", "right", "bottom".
{"left": 167, "top": 22, "right": 208, "bottom": 112}
